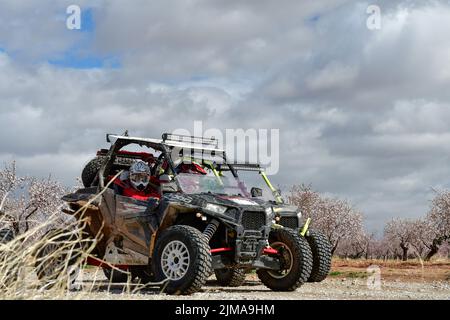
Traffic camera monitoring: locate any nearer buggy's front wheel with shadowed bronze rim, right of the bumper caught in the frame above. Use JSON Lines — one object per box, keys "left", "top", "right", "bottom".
{"left": 257, "top": 228, "right": 313, "bottom": 291}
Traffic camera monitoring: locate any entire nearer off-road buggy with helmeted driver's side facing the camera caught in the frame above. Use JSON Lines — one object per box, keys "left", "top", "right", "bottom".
{"left": 43, "top": 134, "right": 313, "bottom": 294}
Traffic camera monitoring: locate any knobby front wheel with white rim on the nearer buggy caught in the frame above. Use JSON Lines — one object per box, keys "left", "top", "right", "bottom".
{"left": 152, "top": 225, "right": 211, "bottom": 295}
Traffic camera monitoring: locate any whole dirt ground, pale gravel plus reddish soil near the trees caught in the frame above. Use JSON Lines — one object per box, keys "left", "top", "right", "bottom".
{"left": 69, "top": 260, "right": 450, "bottom": 300}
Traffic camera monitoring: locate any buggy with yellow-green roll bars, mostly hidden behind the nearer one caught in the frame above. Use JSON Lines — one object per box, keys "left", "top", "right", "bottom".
{"left": 217, "top": 163, "right": 332, "bottom": 282}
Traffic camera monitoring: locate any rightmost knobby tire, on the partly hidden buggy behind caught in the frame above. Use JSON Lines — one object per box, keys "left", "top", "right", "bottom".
{"left": 306, "top": 230, "right": 331, "bottom": 282}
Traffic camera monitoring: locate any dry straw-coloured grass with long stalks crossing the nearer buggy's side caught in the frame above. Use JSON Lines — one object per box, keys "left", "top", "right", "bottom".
{"left": 0, "top": 173, "right": 171, "bottom": 299}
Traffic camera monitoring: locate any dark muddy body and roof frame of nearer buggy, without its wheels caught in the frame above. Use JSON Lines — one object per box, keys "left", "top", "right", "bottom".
{"left": 63, "top": 134, "right": 280, "bottom": 282}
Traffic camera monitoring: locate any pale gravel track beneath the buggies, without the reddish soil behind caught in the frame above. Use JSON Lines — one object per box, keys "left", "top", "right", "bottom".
{"left": 69, "top": 272, "right": 450, "bottom": 300}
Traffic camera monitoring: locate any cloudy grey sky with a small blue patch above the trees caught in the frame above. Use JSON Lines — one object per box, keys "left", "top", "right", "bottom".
{"left": 0, "top": 0, "right": 450, "bottom": 230}
